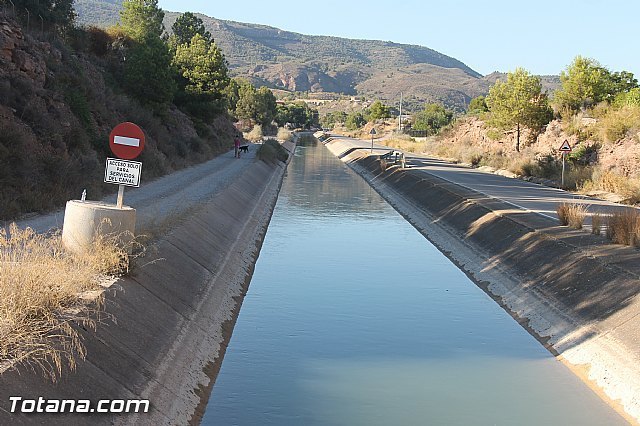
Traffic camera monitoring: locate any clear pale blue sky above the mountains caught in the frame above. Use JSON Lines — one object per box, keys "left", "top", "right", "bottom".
{"left": 159, "top": 0, "right": 640, "bottom": 77}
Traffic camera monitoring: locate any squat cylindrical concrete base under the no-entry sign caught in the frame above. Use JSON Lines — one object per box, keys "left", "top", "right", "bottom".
{"left": 62, "top": 200, "right": 136, "bottom": 253}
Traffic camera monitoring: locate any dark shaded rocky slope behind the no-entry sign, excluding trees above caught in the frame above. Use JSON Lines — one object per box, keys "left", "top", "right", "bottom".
{"left": 0, "top": 13, "right": 234, "bottom": 220}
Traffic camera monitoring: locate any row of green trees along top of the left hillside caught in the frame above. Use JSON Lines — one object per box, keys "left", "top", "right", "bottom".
{"left": 115, "top": 0, "right": 317, "bottom": 127}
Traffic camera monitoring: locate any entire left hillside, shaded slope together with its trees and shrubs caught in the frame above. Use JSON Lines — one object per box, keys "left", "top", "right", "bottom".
{"left": 0, "top": 0, "right": 317, "bottom": 220}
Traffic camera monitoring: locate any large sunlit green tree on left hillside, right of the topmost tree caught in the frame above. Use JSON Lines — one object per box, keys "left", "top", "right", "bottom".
{"left": 173, "top": 33, "right": 229, "bottom": 119}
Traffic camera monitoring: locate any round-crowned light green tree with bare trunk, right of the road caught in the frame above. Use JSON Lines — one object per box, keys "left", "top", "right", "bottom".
{"left": 486, "top": 68, "right": 553, "bottom": 151}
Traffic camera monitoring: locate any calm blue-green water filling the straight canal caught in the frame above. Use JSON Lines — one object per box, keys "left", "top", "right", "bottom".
{"left": 202, "top": 144, "right": 624, "bottom": 426}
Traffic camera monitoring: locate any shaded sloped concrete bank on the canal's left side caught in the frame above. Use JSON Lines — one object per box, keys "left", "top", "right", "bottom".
{"left": 0, "top": 144, "right": 292, "bottom": 425}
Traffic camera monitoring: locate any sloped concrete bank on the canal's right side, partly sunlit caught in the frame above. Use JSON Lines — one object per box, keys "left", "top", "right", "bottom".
{"left": 327, "top": 141, "right": 640, "bottom": 423}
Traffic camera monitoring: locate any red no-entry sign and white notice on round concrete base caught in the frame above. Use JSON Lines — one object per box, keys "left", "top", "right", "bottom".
{"left": 62, "top": 122, "right": 145, "bottom": 253}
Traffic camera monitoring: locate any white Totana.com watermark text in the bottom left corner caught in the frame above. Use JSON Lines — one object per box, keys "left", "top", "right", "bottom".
{"left": 9, "top": 396, "right": 149, "bottom": 413}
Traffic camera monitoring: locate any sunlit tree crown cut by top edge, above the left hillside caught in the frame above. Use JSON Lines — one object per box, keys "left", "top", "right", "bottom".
{"left": 120, "top": 0, "right": 164, "bottom": 42}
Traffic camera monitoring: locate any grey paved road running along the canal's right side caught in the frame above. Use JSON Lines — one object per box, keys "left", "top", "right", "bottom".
{"left": 334, "top": 136, "right": 628, "bottom": 220}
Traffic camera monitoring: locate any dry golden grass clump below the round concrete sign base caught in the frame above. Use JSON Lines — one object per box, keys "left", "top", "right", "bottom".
{"left": 0, "top": 224, "right": 129, "bottom": 381}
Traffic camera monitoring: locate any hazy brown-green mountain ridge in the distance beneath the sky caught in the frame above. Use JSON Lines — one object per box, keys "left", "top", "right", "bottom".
{"left": 76, "top": 0, "right": 556, "bottom": 110}
